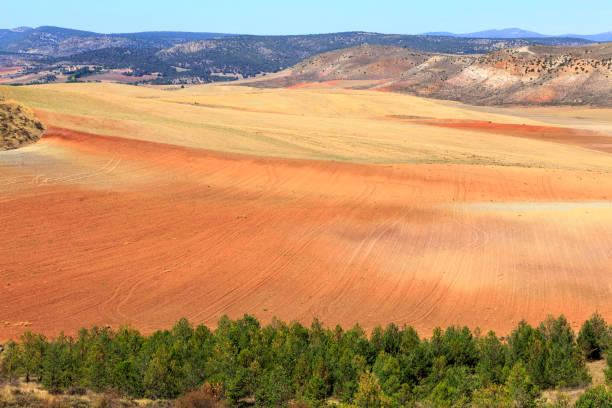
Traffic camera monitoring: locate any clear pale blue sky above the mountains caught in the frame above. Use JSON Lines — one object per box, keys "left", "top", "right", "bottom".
{"left": 0, "top": 0, "right": 612, "bottom": 35}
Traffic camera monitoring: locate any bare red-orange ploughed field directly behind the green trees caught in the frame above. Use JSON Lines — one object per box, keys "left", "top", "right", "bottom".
{"left": 0, "top": 127, "right": 612, "bottom": 340}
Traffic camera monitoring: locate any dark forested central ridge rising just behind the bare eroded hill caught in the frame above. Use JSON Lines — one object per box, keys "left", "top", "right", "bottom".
{"left": 45, "top": 32, "right": 590, "bottom": 83}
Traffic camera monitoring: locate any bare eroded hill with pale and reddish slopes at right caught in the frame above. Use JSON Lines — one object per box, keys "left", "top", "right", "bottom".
{"left": 249, "top": 43, "right": 612, "bottom": 106}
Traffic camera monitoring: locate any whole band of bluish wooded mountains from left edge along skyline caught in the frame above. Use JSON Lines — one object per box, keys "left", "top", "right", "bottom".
{"left": 0, "top": 26, "right": 592, "bottom": 84}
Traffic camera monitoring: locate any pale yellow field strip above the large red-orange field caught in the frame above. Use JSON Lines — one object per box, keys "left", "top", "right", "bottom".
{"left": 0, "top": 84, "right": 612, "bottom": 170}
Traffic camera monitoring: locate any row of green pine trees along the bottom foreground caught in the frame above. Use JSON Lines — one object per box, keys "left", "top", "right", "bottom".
{"left": 0, "top": 313, "right": 612, "bottom": 408}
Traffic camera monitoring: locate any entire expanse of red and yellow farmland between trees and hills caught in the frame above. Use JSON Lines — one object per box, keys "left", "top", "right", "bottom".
{"left": 0, "top": 84, "right": 612, "bottom": 340}
